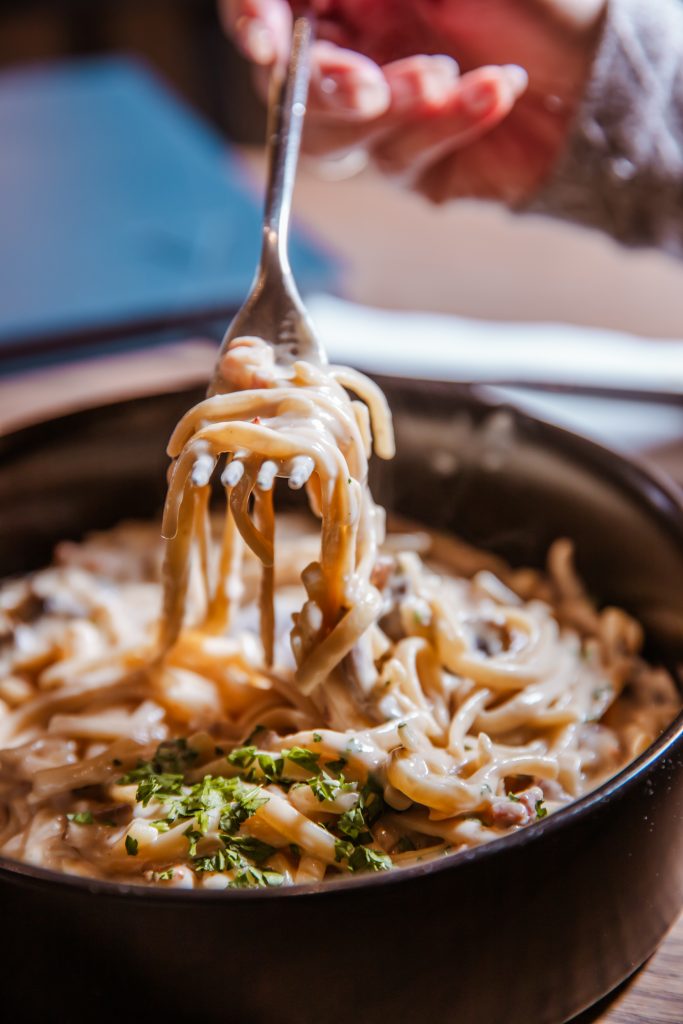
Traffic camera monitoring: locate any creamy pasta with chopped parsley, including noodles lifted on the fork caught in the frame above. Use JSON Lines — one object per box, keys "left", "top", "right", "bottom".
{"left": 0, "top": 339, "right": 680, "bottom": 889}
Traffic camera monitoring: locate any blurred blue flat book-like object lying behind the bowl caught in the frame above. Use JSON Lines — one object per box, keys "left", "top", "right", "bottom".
{"left": 0, "top": 57, "right": 335, "bottom": 358}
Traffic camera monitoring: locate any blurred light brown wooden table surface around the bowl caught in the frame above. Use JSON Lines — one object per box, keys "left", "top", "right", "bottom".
{"left": 0, "top": 151, "right": 683, "bottom": 1024}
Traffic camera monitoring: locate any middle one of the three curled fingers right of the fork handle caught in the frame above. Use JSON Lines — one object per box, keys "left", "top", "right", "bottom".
{"left": 304, "top": 54, "right": 459, "bottom": 157}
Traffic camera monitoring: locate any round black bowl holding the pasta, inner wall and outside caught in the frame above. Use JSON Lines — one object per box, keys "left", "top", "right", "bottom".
{"left": 0, "top": 379, "right": 683, "bottom": 1024}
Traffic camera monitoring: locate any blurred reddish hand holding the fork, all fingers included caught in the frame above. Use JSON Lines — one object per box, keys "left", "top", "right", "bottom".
{"left": 220, "top": 0, "right": 606, "bottom": 205}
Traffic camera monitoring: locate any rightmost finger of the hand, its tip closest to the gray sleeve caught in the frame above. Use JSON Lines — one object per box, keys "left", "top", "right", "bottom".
{"left": 371, "top": 66, "right": 527, "bottom": 177}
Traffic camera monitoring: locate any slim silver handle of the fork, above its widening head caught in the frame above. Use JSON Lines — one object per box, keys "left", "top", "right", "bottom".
{"left": 262, "top": 13, "right": 315, "bottom": 270}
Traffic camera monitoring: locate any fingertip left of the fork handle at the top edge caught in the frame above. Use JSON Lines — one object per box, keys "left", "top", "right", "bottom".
{"left": 219, "top": 0, "right": 292, "bottom": 67}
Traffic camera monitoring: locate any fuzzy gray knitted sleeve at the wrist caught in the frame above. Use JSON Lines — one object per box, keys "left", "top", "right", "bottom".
{"left": 526, "top": 0, "right": 683, "bottom": 256}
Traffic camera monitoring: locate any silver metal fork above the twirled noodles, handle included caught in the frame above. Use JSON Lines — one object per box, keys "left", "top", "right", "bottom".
{"left": 208, "top": 14, "right": 327, "bottom": 395}
